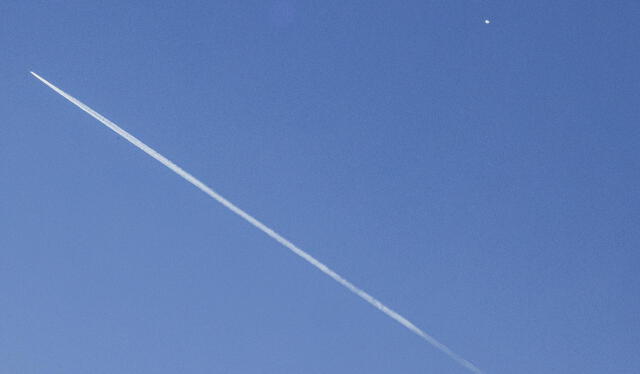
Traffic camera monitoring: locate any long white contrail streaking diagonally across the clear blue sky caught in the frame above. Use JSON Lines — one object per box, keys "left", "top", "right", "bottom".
{"left": 31, "top": 72, "right": 482, "bottom": 374}
